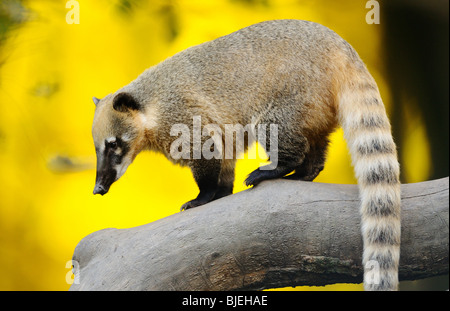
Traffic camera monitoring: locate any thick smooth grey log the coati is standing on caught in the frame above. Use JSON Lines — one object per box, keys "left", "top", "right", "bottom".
{"left": 70, "top": 177, "right": 449, "bottom": 290}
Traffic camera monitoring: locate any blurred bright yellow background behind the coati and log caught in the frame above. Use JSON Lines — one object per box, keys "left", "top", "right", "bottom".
{"left": 0, "top": 0, "right": 429, "bottom": 290}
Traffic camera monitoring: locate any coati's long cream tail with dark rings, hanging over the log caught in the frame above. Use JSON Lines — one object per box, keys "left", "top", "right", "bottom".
{"left": 338, "top": 69, "right": 401, "bottom": 290}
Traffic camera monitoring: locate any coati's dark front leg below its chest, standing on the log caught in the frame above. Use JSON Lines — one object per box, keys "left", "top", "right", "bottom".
{"left": 180, "top": 159, "right": 222, "bottom": 211}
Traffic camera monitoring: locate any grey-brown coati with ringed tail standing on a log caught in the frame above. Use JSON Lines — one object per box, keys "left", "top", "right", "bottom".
{"left": 92, "top": 20, "right": 400, "bottom": 290}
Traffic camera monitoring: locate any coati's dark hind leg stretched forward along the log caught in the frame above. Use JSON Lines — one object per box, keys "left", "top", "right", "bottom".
{"left": 245, "top": 136, "right": 309, "bottom": 186}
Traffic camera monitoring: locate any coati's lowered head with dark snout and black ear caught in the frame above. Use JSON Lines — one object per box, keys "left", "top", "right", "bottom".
{"left": 92, "top": 92, "right": 145, "bottom": 195}
